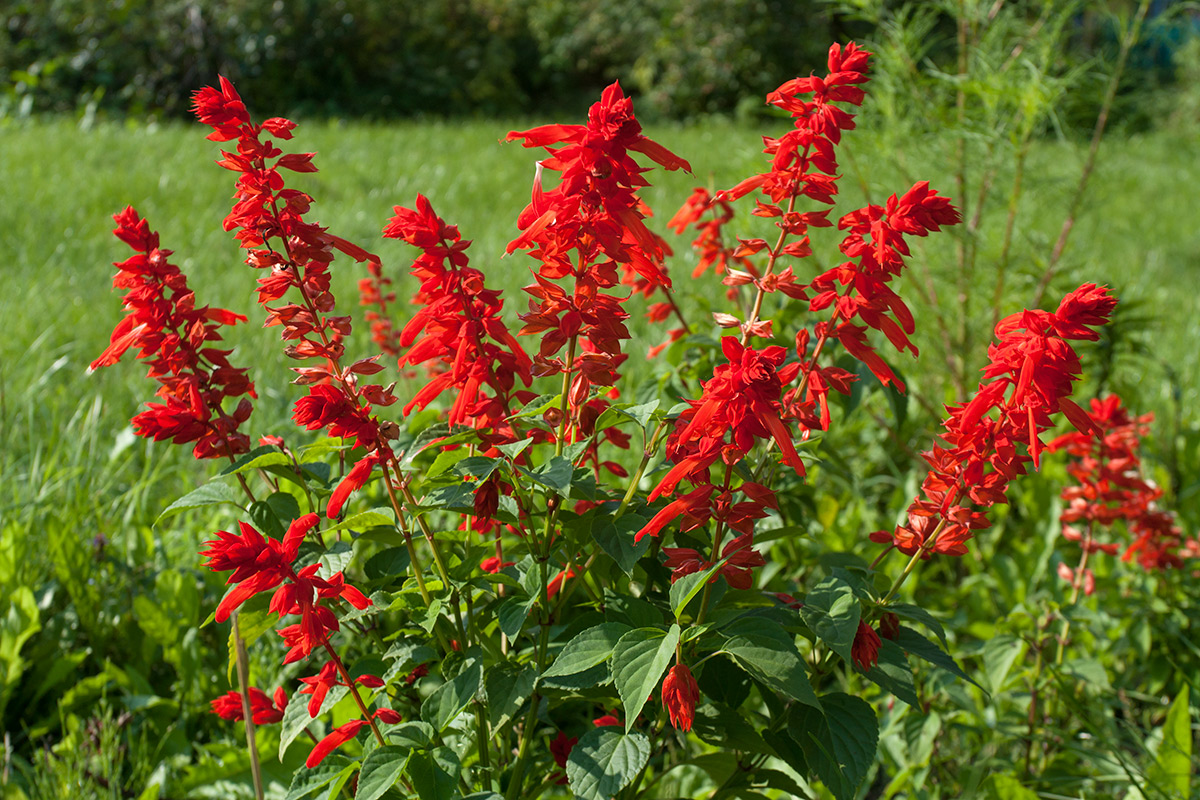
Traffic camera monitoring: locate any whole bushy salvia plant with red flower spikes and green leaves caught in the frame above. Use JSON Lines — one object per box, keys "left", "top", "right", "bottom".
{"left": 92, "top": 43, "right": 1178, "bottom": 800}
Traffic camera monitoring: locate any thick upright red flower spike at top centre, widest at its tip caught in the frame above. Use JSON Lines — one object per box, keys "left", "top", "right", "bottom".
{"left": 508, "top": 84, "right": 691, "bottom": 429}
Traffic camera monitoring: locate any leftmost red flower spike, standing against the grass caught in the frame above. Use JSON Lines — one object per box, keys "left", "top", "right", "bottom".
{"left": 89, "top": 207, "right": 257, "bottom": 458}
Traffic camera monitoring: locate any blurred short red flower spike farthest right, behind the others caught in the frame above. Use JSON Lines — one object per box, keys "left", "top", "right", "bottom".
{"left": 1046, "top": 395, "right": 1183, "bottom": 582}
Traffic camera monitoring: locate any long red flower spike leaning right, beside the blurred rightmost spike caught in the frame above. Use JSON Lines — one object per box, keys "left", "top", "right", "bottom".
{"left": 871, "top": 283, "right": 1116, "bottom": 558}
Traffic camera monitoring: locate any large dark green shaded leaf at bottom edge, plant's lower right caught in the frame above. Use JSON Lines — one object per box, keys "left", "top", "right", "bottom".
{"left": 787, "top": 692, "right": 880, "bottom": 800}
